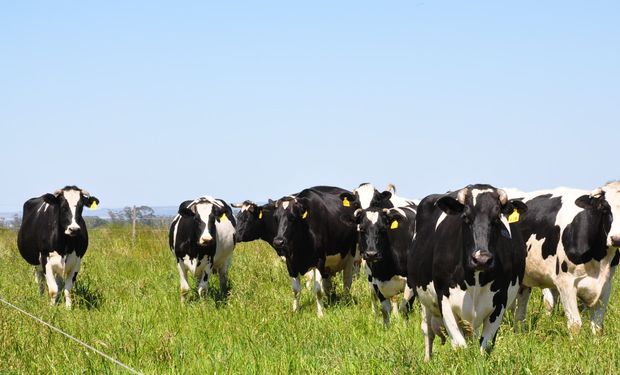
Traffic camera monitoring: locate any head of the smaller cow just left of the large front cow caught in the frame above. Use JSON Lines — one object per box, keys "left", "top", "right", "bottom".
{"left": 353, "top": 208, "right": 406, "bottom": 263}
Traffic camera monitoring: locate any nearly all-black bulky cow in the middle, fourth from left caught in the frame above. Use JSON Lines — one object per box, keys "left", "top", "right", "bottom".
{"left": 273, "top": 186, "right": 356, "bottom": 317}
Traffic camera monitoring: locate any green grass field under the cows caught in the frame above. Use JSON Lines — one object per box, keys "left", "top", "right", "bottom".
{"left": 0, "top": 227, "right": 620, "bottom": 374}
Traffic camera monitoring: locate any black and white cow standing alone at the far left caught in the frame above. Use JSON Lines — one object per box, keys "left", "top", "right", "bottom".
{"left": 17, "top": 186, "right": 99, "bottom": 308}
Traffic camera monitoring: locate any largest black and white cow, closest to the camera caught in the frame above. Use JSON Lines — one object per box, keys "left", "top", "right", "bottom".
{"left": 407, "top": 185, "right": 527, "bottom": 360}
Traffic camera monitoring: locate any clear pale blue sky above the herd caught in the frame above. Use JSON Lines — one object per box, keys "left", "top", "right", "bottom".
{"left": 0, "top": 1, "right": 620, "bottom": 212}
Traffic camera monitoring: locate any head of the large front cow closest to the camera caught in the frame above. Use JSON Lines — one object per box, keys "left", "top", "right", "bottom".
{"left": 436, "top": 185, "right": 527, "bottom": 271}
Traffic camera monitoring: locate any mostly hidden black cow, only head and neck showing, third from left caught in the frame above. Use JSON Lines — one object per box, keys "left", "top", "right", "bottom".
{"left": 232, "top": 199, "right": 284, "bottom": 258}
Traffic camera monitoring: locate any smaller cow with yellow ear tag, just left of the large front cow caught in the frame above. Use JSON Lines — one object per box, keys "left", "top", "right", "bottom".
{"left": 344, "top": 206, "right": 416, "bottom": 327}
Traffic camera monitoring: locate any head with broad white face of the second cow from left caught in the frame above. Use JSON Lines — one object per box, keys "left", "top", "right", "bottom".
{"left": 179, "top": 196, "right": 228, "bottom": 246}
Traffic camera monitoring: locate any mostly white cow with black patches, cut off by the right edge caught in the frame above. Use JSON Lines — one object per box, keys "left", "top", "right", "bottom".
{"left": 508, "top": 181, "right": 620, "bottom": 335}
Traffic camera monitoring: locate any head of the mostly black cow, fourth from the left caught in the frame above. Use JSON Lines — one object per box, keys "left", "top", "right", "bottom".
{"left": 273, "top": 197, "right": 309, "bottom": 253}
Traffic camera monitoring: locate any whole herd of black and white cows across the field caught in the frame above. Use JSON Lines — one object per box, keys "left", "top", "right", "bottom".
{"left": 17, "top": 181, "right": 620, "bottom": 360}
